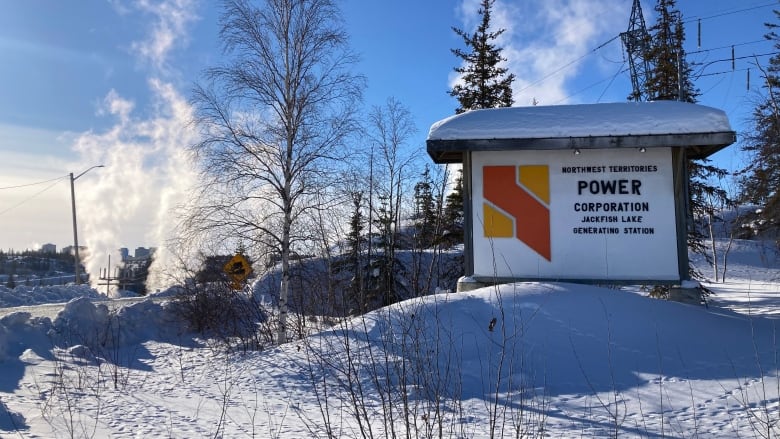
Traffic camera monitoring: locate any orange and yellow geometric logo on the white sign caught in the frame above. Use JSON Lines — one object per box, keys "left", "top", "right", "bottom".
{"left": 482, "top": 165, "right": 552, "bottom": 261}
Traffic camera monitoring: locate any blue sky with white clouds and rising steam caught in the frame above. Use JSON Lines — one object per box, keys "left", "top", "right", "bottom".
{"left": 0, "top": 0, "right": 778, "bottom": 258}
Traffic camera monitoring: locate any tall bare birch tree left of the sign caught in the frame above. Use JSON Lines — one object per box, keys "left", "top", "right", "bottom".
{"left": 192, "top": 0, "right": 364, "bottom": 343}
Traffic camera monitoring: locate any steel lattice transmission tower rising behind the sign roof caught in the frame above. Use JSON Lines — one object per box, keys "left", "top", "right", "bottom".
{"left": 620, "top": 0, "right": 650, "bottom": 101}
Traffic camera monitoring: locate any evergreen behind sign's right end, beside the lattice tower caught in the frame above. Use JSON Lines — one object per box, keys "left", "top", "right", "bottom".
{"left": 645, "top": 0, "right": 729, "bottom": 268}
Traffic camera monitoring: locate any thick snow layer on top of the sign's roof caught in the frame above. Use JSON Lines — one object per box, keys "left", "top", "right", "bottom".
{"left": 428, "top": 101, "right": 732, "bottom": 140}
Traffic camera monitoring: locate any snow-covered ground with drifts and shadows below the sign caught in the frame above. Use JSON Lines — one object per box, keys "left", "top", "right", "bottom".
{"left": 0, "top": 241, "right": 780, "bottom": 438}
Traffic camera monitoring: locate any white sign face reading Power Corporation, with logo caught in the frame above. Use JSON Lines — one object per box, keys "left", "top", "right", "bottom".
{"left": 472, "top": 148, "right": 680, "bottom": 281}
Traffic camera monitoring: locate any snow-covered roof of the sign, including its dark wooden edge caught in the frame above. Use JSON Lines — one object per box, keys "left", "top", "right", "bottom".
{"left": 427, "top": 101, "right": 736, "bottom": 163}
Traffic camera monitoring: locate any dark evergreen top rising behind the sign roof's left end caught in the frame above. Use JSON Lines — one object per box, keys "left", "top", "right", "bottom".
{"left": 450, "top": 0, "right": 515, "bottom": 114}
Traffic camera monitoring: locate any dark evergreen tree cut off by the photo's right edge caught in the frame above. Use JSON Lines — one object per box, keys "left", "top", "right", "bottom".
{"left": 739, "top": 10, "right": 780, "bottom": 235}
